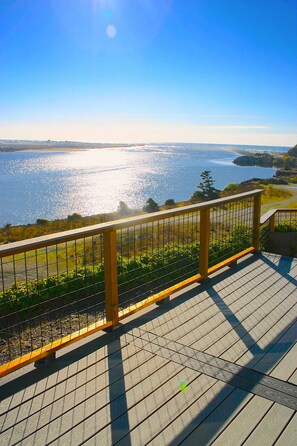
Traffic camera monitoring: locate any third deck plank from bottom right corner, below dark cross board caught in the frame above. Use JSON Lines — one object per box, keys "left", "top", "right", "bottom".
{"left": 212, "top": 396, "right": 273, "bottom": 446}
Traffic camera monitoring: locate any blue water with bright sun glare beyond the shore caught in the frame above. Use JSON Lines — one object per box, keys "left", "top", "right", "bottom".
{"left": 0, "top": 144, "right": 287, "bottom": 226}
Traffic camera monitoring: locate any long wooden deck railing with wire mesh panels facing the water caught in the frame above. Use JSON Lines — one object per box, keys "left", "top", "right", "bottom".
{"left": 0, "top": 190, "right": 262, "bottom": 376}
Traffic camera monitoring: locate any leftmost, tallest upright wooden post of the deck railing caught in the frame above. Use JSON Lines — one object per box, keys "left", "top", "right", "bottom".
{"left": 103, "top": 230, "right": 119, "bottom": 327}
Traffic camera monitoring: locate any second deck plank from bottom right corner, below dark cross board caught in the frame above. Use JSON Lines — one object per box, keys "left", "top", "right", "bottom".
{"left": 243, "top": 404, "right": 294, "bottom": 446}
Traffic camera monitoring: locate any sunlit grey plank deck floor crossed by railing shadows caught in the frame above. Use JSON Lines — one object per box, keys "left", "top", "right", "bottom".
{"left": 0, "top": 254, "right": 297, "bottom": 446}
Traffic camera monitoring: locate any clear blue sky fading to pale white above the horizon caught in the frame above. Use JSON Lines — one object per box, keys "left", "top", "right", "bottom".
{"left": 0, "top": 0, "right": 297, "bottom": 147}
